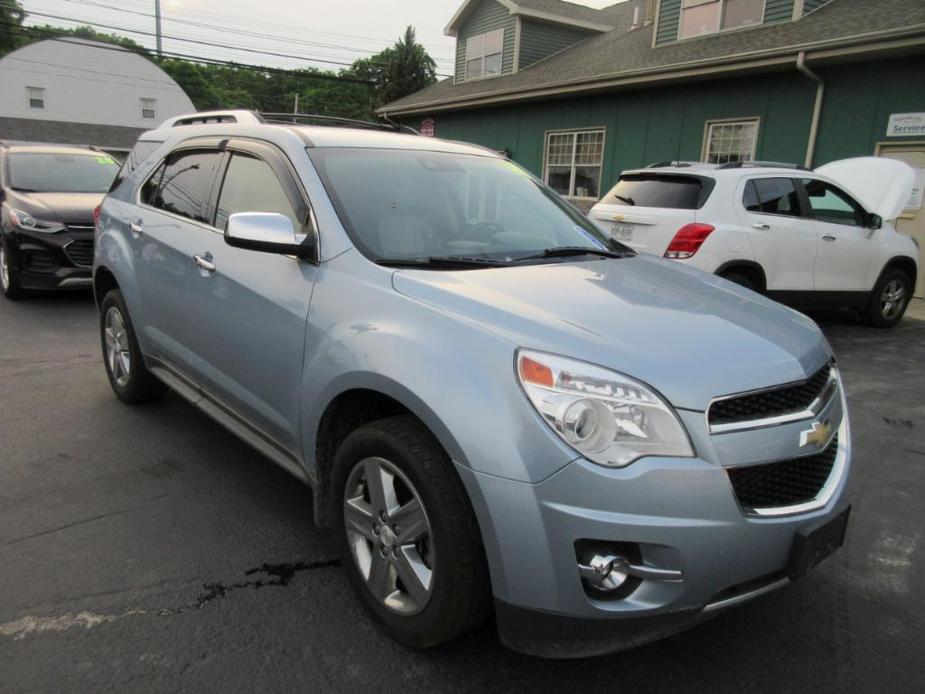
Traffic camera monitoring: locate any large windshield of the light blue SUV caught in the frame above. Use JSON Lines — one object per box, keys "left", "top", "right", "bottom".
{"left": 310, "top": 148, "right": 629, "bottom": 263}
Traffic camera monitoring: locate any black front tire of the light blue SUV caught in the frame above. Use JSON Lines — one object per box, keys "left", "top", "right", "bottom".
{"left": 331, "top": 415, "right": 491, "bottom": 648}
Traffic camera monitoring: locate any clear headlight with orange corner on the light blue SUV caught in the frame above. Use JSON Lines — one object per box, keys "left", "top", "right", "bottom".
{"left": 517, "top": 350, "right": 694, "bottom": 467}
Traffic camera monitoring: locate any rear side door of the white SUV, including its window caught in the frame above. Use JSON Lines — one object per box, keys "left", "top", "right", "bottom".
{"left": 737, "top": 176, "right": 819, "bottom": 291}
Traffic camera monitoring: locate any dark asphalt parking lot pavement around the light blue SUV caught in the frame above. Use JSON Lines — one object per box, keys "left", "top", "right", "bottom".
{"left": 0, "top": 295, "right": 925, "bottom": 694}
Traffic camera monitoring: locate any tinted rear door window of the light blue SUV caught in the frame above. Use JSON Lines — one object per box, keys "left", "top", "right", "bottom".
{"left": 153, "top": 151, "right": 221, "bottom": 224}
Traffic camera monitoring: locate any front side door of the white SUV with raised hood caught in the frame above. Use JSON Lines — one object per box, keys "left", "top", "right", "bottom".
{"left": 800, "top": 177, "right": 878, "bottom": 291}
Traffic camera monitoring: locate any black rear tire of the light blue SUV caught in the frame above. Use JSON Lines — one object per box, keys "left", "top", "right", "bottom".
{"left": 100, "top": 289, "right": 167, "bottom": 403}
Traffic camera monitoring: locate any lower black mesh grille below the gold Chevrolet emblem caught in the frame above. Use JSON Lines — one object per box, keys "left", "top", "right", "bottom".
{"left": 728, "top": 435, "right": 838, "bottom": 511}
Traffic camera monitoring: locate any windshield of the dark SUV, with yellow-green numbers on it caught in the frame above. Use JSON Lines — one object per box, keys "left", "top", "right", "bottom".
{"left": 9, "top": 152, "right": 119, "bottom": 193}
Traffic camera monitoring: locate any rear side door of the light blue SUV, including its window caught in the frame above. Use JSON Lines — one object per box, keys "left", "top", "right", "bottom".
{"left": 127, "top": 147, "right": 223, "bottom": 373}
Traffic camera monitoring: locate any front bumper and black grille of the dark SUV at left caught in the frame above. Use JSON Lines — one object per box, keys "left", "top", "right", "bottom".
{"left": 4, "top": 228, "right": 94, "bottom": 291}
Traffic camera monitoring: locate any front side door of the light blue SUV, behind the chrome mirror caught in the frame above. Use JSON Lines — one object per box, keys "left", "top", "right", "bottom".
{"left": 179, "top": 140, "right": 317, "bottom": 457}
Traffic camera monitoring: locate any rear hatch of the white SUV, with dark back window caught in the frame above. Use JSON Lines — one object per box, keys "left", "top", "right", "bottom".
{"left": 589, "top": 170, "right": 716, "bottom": 255}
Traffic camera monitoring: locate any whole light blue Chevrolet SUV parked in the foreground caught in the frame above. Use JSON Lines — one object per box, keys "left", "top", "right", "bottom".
{"left": 94, "top": 117, "right": 850, "bottom": 657}
